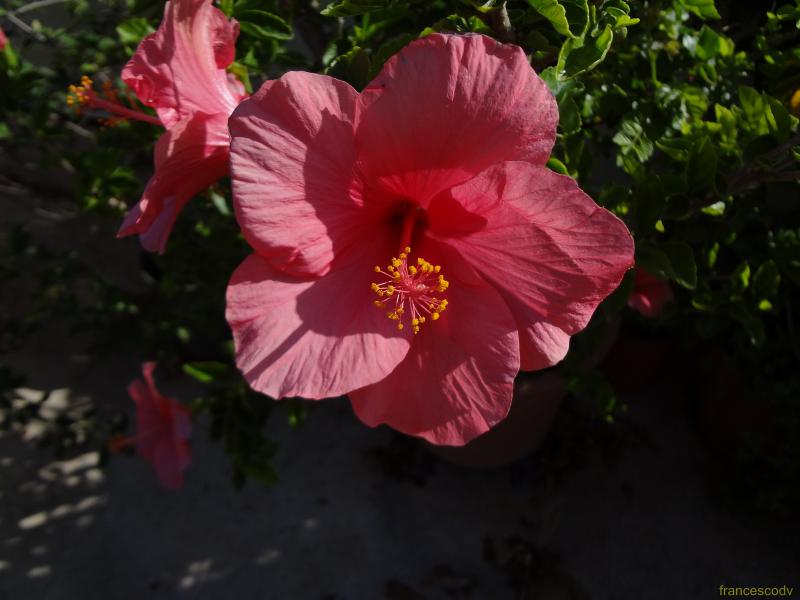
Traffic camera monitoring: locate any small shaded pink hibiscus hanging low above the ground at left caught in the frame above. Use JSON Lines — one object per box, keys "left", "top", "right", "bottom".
{"left": 111, "top": 362, "right": 192, "bottom": 490}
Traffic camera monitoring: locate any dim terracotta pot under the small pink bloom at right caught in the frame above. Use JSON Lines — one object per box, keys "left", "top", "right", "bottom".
{"left": 602, "top": 334, "right": 675, "bottom": 393}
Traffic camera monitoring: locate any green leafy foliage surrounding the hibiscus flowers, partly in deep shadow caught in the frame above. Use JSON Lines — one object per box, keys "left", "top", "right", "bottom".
{"left": 0, "top": 0, "right": 800, "bottom": 511}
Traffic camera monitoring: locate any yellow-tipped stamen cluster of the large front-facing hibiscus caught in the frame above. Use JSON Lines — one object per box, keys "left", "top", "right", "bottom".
{"left": 371, "top": 246, "right": 450, "bottom": 335}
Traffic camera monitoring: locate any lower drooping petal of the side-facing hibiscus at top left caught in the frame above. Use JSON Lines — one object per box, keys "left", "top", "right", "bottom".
{"left": 117, "top": 113, "right": 229, "bottom": 253}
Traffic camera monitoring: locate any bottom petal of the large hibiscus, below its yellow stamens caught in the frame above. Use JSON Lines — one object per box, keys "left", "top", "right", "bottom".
{"left": 350, "top": 251, "right": 520, "bottom": 446}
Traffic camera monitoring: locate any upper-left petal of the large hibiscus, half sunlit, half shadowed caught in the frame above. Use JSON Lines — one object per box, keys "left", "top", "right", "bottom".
{"left": 230, "top": 72, "right": 376, "bottom": 276}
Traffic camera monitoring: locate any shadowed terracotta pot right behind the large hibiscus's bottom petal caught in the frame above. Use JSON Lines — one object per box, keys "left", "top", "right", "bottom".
{"left": 430, "top": 372, "right": 567, "bottom": 468}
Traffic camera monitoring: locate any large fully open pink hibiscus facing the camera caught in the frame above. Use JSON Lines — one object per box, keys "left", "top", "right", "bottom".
{"left": 226, "top": 34, "right": 633, "bottom": 445}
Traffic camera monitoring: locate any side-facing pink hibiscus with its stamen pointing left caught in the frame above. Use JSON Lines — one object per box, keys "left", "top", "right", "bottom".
{"left": 68, "top": 0, "right": 246, "bottom": 252}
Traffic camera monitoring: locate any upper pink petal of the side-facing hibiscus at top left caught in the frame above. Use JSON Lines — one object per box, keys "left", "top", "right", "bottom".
{"left": 122, "top": 0, "right": 241, "bottom": 127}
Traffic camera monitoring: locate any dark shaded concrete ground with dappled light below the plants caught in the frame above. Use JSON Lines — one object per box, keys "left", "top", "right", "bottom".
{"left": 0, "top": 187, "right": 800, "bottom": 600}
